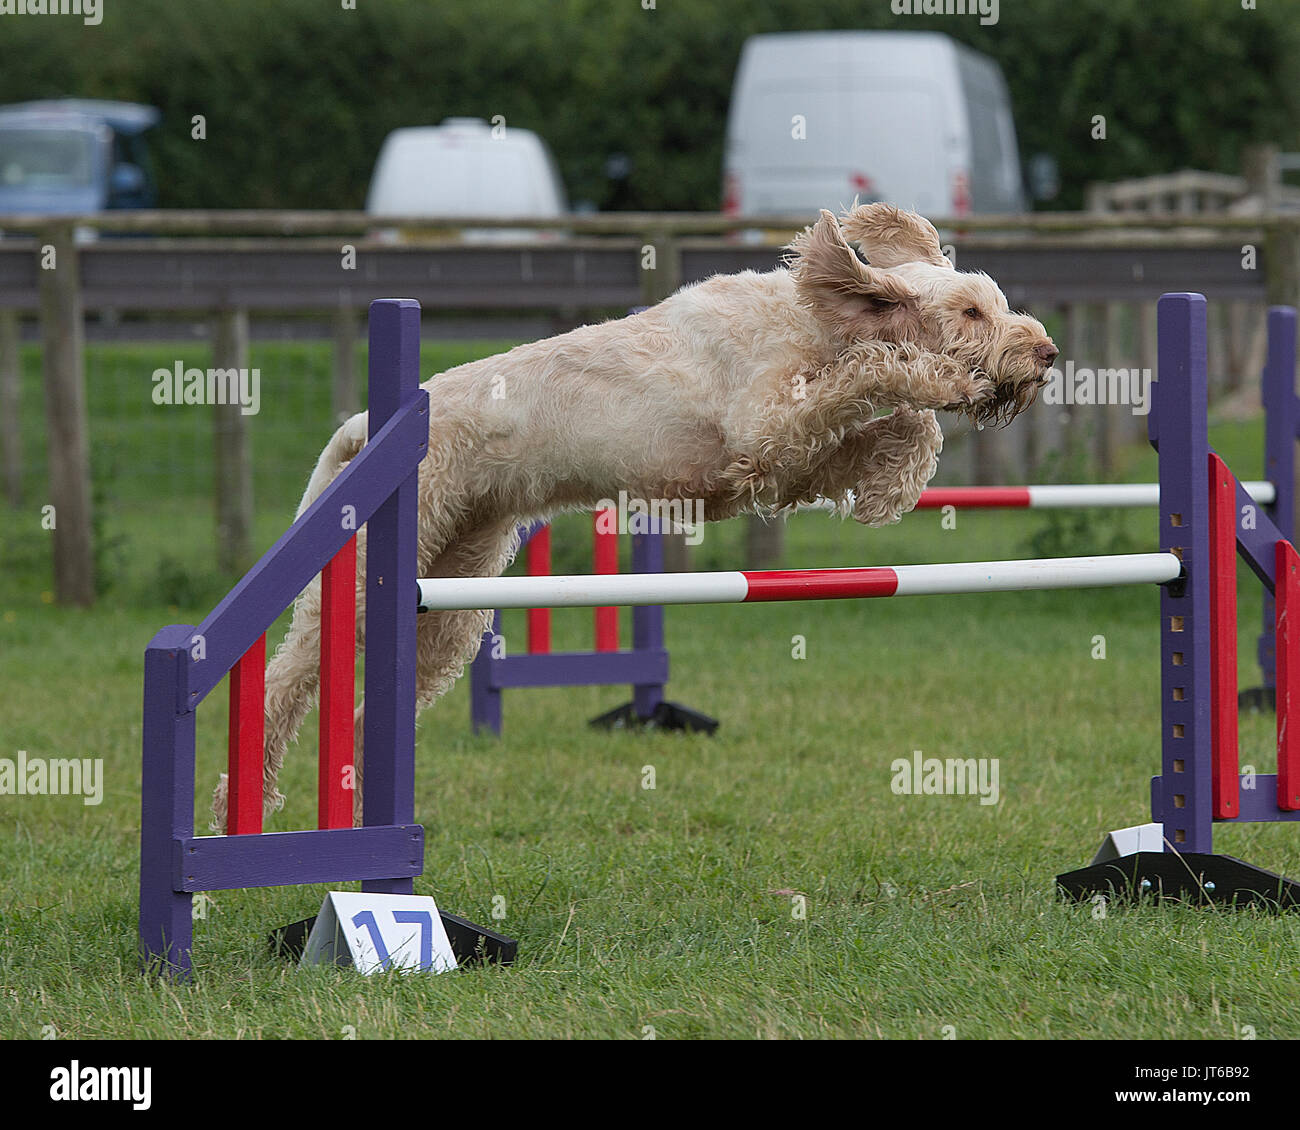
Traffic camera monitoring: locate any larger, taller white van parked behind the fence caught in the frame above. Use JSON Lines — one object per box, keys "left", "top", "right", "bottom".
{"left": 723, "top": 31, "right": 1024, "bottom": 216}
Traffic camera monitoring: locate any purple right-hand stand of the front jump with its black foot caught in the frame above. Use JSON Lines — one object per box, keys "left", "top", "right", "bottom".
{"left": 1057, "top": 294, "right": 1300, "bottom": 906}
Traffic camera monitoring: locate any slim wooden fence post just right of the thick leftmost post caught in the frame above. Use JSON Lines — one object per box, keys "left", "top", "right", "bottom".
{"left": 212, "top": 309, "right": 252, "bottom": 573}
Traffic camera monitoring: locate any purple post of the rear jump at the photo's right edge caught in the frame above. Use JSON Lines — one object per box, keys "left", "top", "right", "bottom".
{"left": 1243, "top": 306, "right": 1300, "bottom": 706}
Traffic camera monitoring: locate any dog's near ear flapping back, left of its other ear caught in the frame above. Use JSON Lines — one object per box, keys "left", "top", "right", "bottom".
{"left": 790, "top": 208, "right": 920, "bottom": 341}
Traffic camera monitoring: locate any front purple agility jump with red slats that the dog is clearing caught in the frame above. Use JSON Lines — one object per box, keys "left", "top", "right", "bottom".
{"left": 139, "top": 294, "right": 1300, "bottom": 977}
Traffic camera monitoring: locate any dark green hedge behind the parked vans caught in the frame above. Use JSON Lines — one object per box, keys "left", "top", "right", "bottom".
{"left": 0, "top": 0, "right": 1300, "bottom": 209}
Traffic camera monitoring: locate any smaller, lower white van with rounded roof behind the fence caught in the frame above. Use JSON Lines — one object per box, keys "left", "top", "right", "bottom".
{"left": 365, "top": 118, "right": 568, "bottom": 231}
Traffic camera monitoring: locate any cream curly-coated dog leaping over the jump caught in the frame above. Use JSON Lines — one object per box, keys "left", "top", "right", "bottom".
{"left": 213, "top": 204, "right": 1057, "bottom": 830}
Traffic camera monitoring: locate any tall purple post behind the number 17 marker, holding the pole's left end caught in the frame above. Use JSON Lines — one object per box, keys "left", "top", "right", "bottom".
{"left": 361, "top": 298, "right": 420, "bottom": 895}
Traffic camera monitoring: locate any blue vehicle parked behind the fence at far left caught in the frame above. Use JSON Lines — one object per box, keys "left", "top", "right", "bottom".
{"left": 0, "top": 99, "right": 161, "bottom": 216}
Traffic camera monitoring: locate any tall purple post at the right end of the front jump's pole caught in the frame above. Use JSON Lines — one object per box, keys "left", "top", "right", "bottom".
{"left": 1148, "top": 294, "right": 1214, "bottom": 853}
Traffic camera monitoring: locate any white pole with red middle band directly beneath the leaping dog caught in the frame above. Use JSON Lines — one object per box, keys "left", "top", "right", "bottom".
{"left": 419, "top": 553, "right": 1182, "bottom": 612}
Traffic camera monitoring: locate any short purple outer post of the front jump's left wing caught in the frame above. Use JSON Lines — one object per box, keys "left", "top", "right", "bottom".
{"left": 139, "top": 624, "right": 194, "bottom": 979}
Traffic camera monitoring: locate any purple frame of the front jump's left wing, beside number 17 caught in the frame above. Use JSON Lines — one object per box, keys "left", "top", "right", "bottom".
{"left": 139, "top": 299, "right": 514, "bottom": 978}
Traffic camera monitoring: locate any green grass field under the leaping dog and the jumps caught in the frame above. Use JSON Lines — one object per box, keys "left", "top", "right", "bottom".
{"left": 0, "top": 346, "right": 1300, "bottom": 1040}
